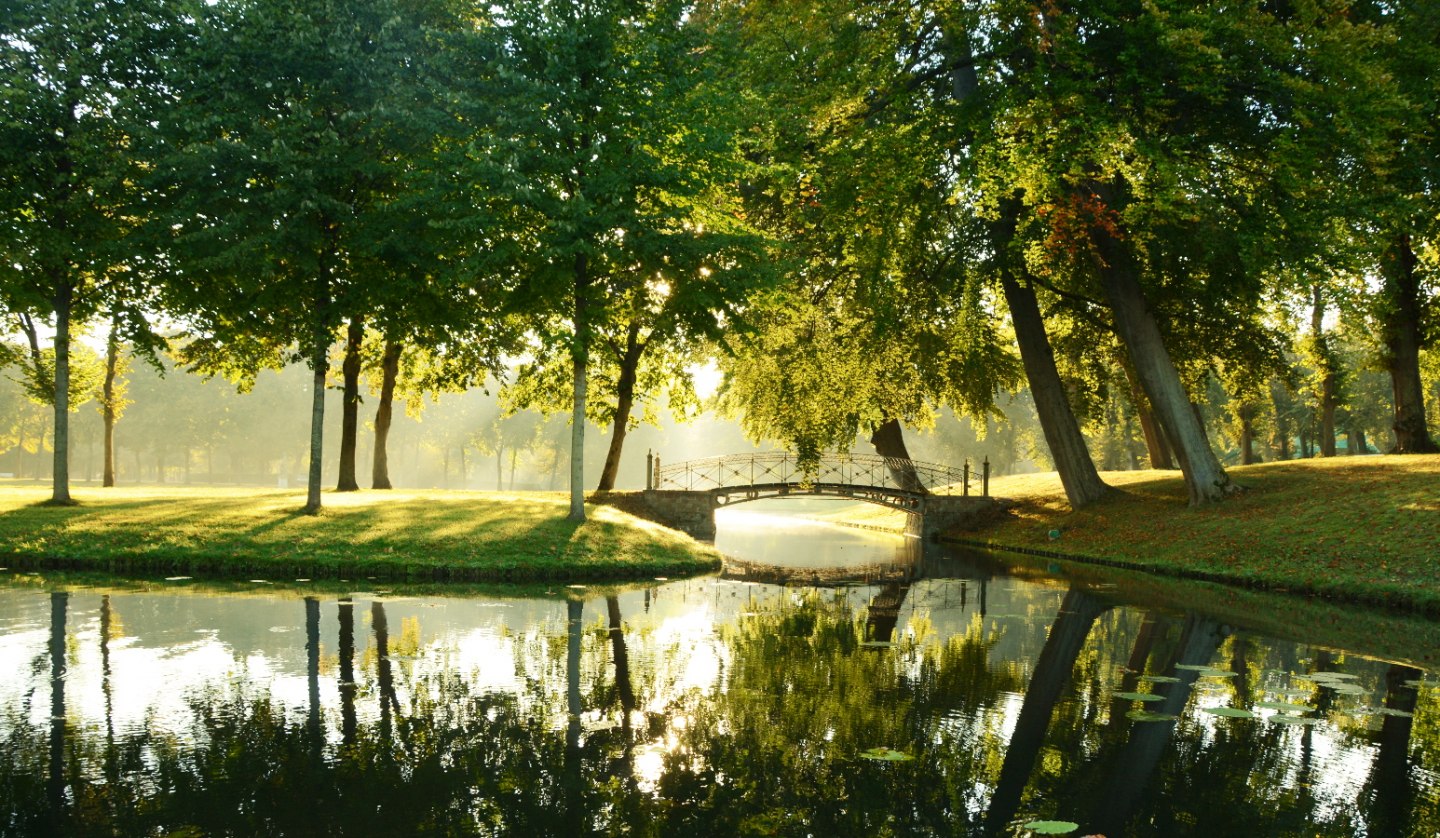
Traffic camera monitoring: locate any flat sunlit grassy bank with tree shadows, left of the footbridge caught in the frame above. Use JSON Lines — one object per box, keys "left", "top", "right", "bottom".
{"left": 0, "top": 487, "right": 720, "bottom": 582}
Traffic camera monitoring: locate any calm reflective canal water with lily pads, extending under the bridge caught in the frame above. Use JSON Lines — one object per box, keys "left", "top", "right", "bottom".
{"left": 0, "top": 518, "right": 1440, "bottom": 838}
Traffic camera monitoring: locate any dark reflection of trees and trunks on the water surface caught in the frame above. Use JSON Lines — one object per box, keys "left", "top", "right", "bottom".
{"left": 0, "top": 590, "right": 1440, "bottom": 835}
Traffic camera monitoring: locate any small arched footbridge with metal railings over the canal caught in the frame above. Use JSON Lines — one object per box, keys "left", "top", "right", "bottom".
{"left": 624, "top": 452, "right": 999, "bottom": 539}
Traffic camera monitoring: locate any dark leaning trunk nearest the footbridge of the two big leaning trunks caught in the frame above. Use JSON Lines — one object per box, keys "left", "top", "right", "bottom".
{"left": 1001, "top": 271, "right": 1110, "bottom": 510}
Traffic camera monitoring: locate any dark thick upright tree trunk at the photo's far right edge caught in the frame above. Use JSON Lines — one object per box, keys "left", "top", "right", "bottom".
{"left": 1376, "top": 235, "right": 1440, "bottom": 454}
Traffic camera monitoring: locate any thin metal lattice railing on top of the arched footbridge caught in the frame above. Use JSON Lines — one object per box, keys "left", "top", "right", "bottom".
{"left": 645, "top": 452, "right": 989, "bottom": 495}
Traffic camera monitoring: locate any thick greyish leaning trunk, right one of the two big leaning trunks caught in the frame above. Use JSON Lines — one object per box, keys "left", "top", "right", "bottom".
{"left": 1094, "top": 211, "right": 1237, "bottom": 505}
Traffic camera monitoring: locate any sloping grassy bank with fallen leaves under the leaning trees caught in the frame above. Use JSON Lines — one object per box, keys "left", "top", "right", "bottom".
{"left": 955, "top": 456, "right": 1440, "bottom": 615}
